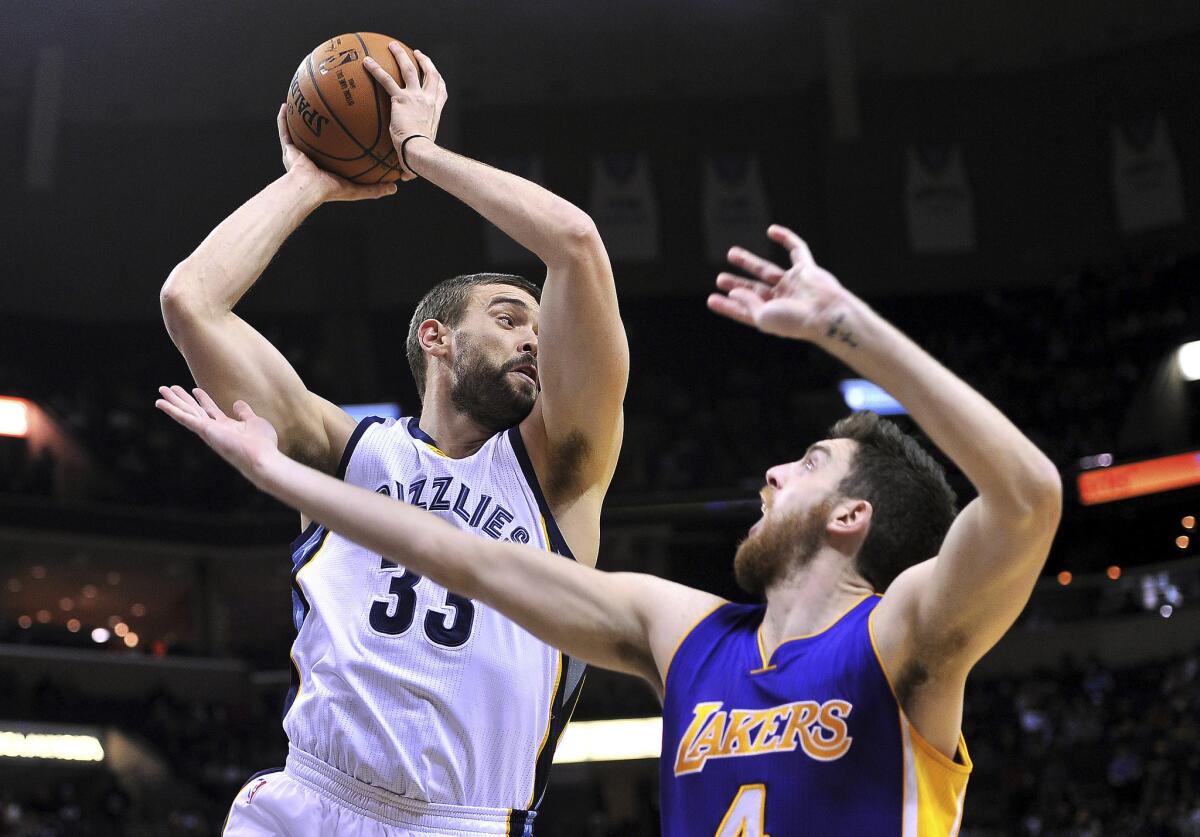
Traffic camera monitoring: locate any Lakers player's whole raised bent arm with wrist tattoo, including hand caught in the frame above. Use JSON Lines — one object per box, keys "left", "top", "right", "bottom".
{"left": 708, "top": 221, "right": 1062, "bottom": 751}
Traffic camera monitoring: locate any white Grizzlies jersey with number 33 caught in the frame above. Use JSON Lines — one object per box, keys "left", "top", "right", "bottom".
{"left": 283, "top": 419, "right": 584, "bottom": 833}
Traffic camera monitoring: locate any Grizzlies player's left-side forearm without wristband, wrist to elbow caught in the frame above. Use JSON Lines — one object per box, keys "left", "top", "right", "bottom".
{"left": 161, "top": 170, "right": 323, "bottom": 317}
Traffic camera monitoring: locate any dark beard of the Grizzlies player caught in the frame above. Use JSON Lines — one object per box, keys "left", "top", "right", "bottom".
{"left": 450, "top": 332, "right": 538, "bottom": 433}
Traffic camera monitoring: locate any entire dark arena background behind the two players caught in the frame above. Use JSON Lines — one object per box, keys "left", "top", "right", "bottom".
{"left": 0, "top": 0, "right": 1200, "bottom": 837}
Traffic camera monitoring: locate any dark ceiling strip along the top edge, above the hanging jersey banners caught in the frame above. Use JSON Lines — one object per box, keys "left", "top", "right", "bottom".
{"left": 0, "top": 0, "right": 1200, "bottom": 122}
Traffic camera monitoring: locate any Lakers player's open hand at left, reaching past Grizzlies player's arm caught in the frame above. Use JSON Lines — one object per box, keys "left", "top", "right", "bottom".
{"left": 155, "top": 386, "right": 280, "bottom": 482}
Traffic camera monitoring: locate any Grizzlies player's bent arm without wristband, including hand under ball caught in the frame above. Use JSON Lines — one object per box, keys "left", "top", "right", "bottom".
{"left": 160, "top": 108, "right": 396, "bottom": 471}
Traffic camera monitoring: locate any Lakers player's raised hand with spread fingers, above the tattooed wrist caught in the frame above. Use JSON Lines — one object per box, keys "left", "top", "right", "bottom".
{"left": 708, "top": 224, "right": 859, "bottom": 347}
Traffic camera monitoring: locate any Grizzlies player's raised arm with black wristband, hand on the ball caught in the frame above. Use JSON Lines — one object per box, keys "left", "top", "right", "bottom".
{"left": 365, "top": 47, "right": 629, "bottom": 546}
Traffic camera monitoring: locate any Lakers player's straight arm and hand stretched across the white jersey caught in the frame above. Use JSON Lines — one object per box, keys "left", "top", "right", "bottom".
{"left": 157, "top": 387, "right": 721, "bottom": 694}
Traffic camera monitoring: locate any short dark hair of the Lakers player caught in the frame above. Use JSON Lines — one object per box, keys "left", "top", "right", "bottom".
{"left": 829, "top": 410, "right": 958, "bottom": 592}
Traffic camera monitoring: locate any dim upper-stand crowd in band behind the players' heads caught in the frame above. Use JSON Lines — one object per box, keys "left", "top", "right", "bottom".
{"left": 0, "top": 248, "right": 1200, "bottom": 511}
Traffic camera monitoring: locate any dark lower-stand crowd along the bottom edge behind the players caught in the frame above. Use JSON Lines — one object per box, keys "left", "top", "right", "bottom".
{"left": 0, "top": 651, "right": 1200, "bottom": 837}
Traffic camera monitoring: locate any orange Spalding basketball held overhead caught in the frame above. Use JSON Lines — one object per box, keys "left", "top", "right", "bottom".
{"left": 287, "top": 32, "right": 419, "bottom": 183}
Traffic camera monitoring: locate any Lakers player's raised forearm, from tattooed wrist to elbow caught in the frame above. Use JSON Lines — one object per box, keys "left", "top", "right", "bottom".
{"left": 820, "top": 293, "right": 1061, "bottom": 514}
